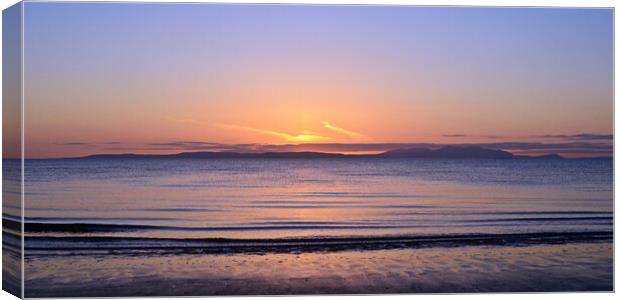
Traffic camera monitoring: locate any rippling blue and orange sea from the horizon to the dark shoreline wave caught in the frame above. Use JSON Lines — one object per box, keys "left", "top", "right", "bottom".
{"left": 12, "top": 158, "right": 613, "bottom": 248}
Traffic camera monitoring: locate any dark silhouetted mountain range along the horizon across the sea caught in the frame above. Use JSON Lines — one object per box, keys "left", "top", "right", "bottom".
{"left": 78, "top": 146, "right": 576, "bottom": 159}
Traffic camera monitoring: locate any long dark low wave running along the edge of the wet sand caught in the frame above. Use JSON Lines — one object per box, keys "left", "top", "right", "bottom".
{"left": 13, "top": 231, "right": 613, "bottom": 256}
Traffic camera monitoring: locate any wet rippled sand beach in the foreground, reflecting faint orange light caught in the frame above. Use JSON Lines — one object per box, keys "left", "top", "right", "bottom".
{"left": 25, "top": 242, "right": 613, "bottom": 297}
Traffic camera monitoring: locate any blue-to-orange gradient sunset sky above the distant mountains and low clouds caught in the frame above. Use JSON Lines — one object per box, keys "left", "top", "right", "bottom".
{"left": 19, "top": 2, "right": 613, "bottom": 157}
